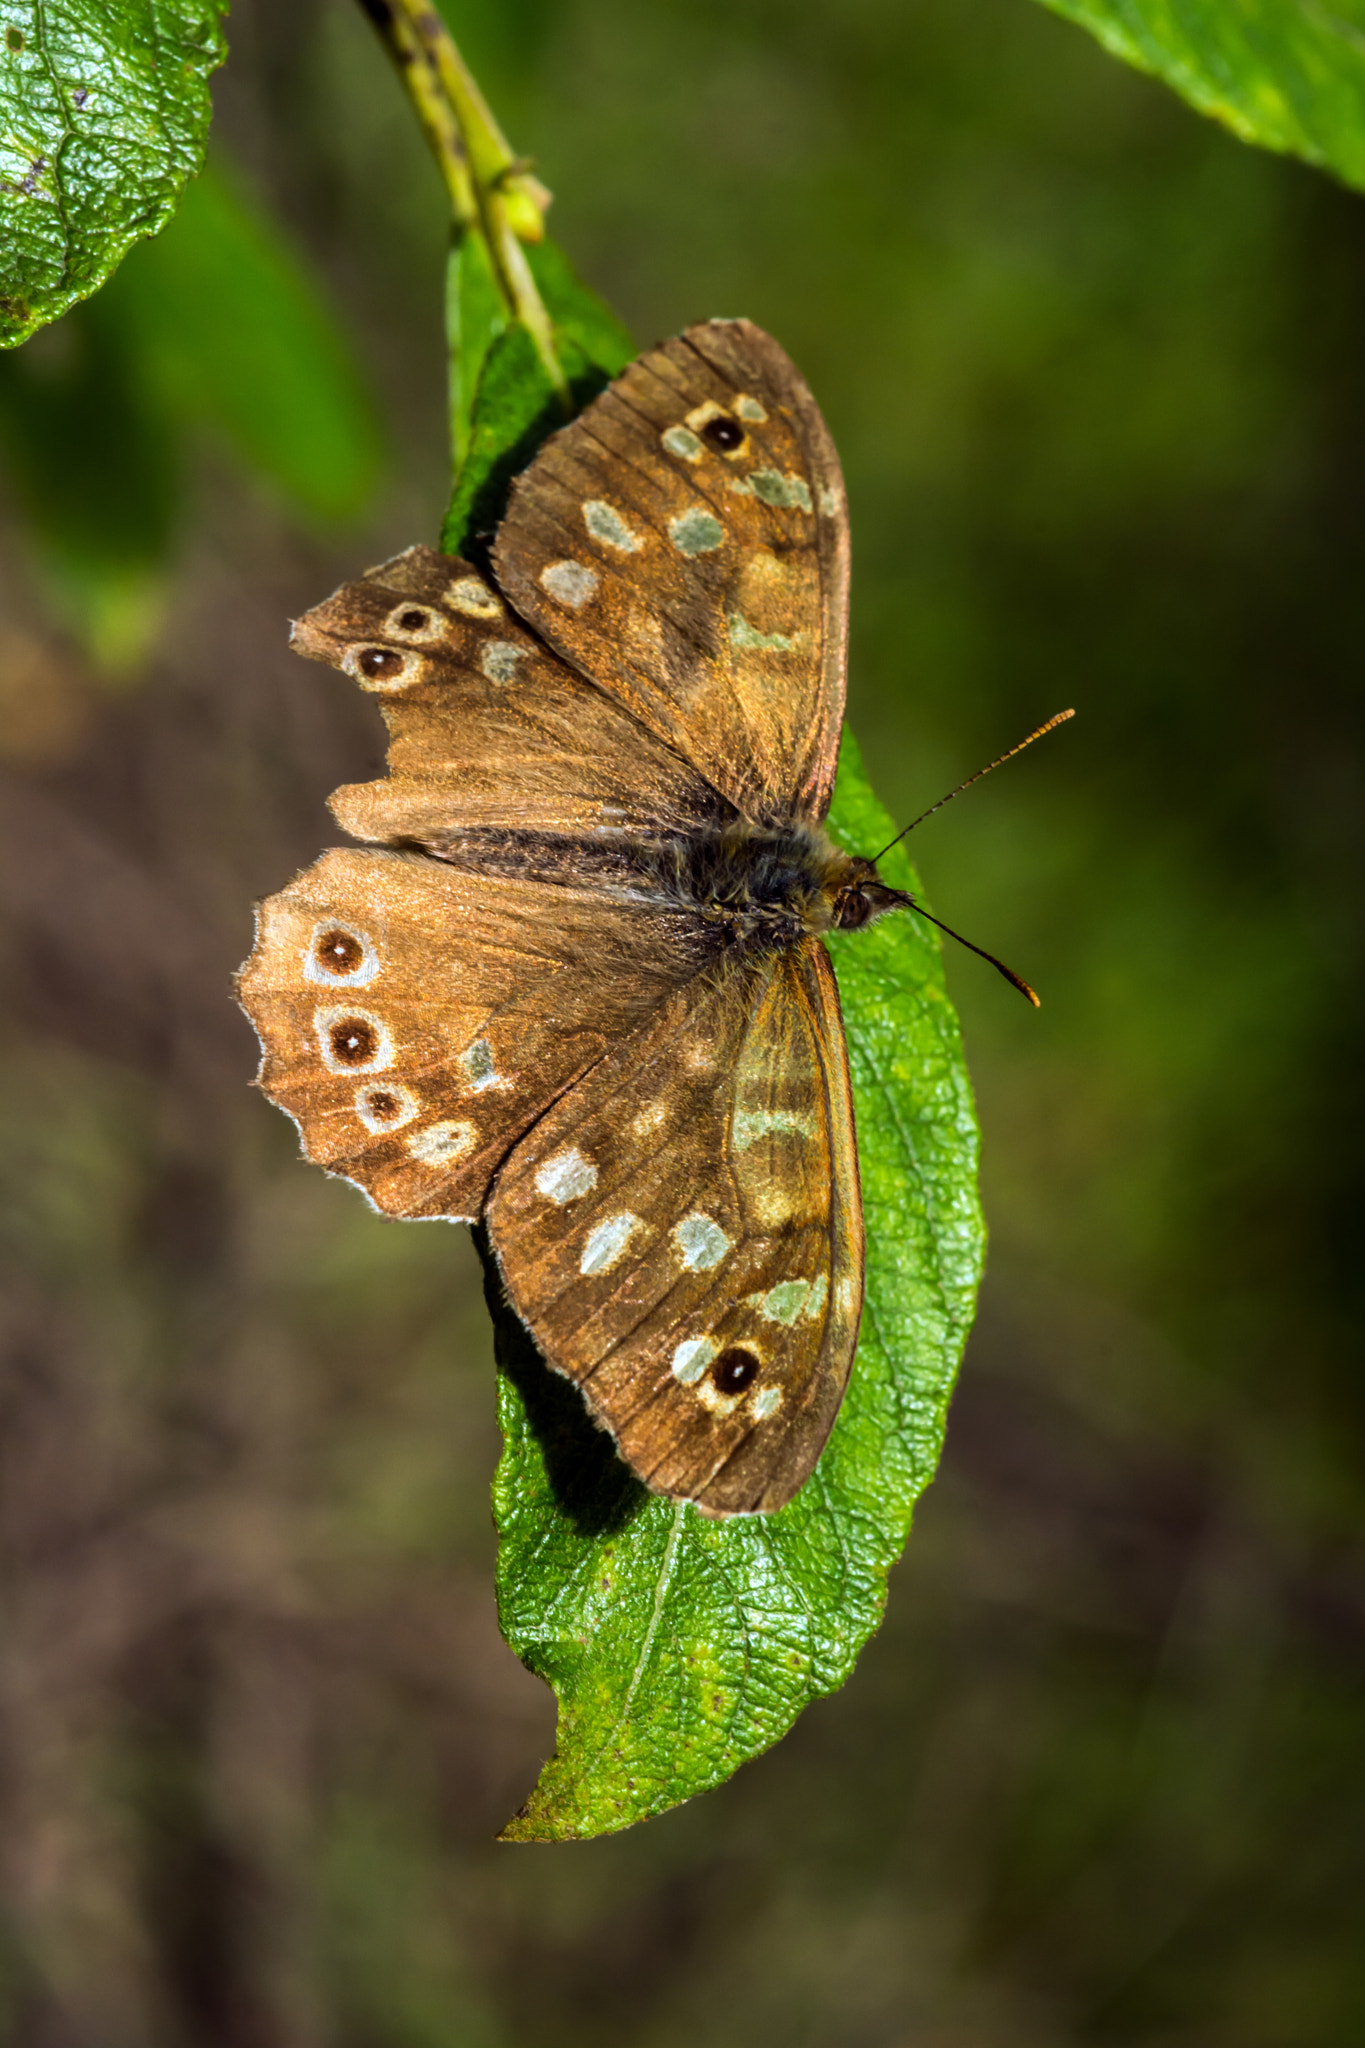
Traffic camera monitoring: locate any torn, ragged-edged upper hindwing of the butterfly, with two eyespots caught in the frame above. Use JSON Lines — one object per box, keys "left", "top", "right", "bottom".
{"left": 293, "top": 547, "right": 735, "bottom": 858}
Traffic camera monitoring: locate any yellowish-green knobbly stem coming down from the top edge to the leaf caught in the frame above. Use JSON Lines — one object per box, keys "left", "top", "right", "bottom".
{"left": 360, "top": 0, "right": 573, "bottom": 414}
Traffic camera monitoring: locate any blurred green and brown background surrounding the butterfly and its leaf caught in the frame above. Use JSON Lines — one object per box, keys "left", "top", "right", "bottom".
{"left": 0, "top": 0, "right": 1365, "bottom": 2048}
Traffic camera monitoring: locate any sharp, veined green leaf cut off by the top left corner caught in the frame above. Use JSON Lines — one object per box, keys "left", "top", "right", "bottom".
{"left": 0, "top": 0, "right": 227, "bottom": 348}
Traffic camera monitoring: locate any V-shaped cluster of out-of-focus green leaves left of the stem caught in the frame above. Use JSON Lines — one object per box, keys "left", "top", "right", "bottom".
{"left": 0, "top": 170, "right": 381, "bottom": 674}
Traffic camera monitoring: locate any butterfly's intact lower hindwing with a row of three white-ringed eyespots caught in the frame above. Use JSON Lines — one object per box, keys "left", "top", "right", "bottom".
{"left": 237, "top": 848, "right": 702, "bottom": 1221}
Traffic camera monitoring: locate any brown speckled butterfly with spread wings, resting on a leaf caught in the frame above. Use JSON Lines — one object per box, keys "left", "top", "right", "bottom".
{"left": 239, "top": 319, "right": 911, "bottom": 1516}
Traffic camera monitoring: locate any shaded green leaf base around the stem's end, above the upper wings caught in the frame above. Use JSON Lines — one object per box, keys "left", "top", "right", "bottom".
{"left": 440, "top": 233, "right": 634, "bottom": 555}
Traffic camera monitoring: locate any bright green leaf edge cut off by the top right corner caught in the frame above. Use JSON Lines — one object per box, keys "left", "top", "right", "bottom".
{"left": 1044, "top": 0, "right": 1365, "bottom": 190}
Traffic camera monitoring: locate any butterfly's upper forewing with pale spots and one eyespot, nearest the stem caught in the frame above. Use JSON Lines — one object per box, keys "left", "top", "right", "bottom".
{"left": 493, "top": 319, "right": 849, "bottom": 821}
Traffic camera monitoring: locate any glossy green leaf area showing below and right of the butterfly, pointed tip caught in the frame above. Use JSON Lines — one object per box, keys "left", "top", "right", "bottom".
{"left": 489, "top": 733, "right": 984, "bottom": 1841}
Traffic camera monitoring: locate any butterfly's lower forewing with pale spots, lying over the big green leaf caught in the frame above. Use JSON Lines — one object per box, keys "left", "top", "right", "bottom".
{"left": 489, "top": 940, "right": 864, "bottom": 1513}
